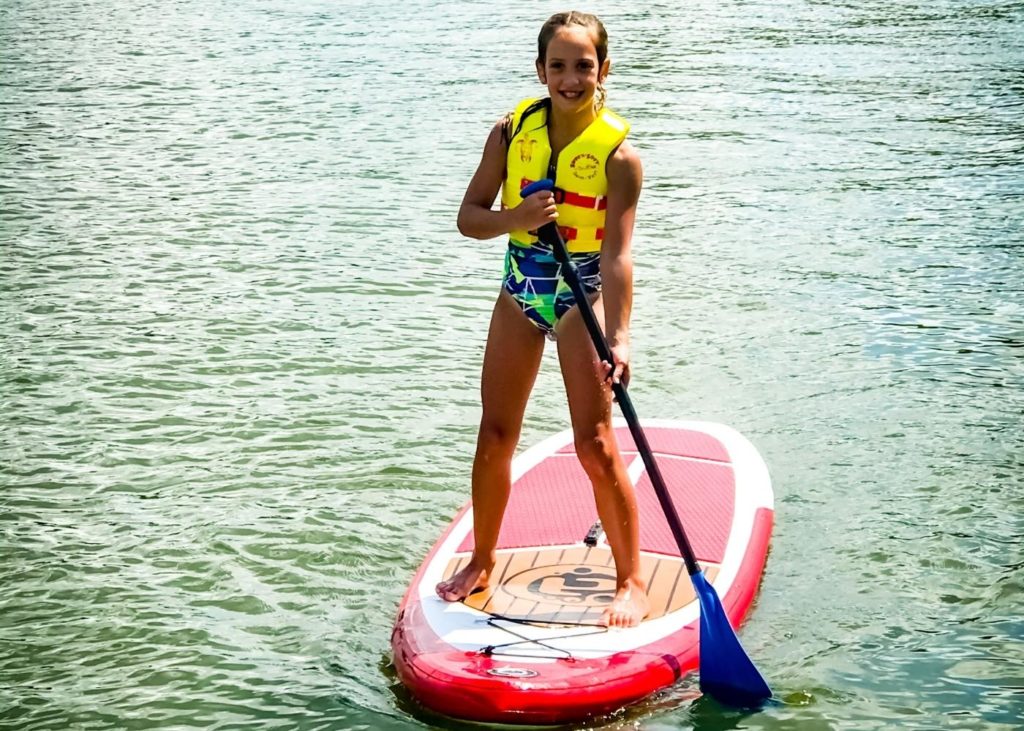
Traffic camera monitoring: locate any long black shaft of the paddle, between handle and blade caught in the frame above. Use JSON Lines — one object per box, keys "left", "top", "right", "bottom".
{"left": 538, "top": 223, "right": 700, "bottom": 576}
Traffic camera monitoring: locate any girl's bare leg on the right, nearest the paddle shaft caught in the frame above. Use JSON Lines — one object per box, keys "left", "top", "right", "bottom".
{"left": 558, "top": 296, "right": 649, "bottom": 627}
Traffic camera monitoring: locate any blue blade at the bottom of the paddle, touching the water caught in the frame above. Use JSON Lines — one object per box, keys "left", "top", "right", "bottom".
{"left": 690, "top": 571, "right": 771, "bottom": 708}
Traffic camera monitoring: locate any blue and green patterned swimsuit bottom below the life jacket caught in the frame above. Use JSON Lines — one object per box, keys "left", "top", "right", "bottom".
{"left": 503, "top": 242, "right": 601, "bottom": 340}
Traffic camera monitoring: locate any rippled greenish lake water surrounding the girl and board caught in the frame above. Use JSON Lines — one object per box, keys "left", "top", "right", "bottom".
{"left": 0, "top": 0, "right": 1024, "bottom": 731}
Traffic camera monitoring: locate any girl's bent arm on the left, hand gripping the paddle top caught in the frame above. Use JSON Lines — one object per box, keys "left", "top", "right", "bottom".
{"left": 458, "top": 120, "right": 558, "bottom": 239}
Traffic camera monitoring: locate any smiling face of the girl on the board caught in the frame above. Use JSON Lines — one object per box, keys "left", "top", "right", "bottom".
{"left": 537, "top": 26, "right": 610, "bottom": 114}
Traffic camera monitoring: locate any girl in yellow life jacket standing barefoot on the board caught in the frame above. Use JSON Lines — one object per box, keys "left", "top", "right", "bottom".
{"left": 437, "top": 12, "right": 648, "bottom": 627}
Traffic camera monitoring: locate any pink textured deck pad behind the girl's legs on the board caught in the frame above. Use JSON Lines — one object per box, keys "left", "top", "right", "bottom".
{"left": 459, "top": 428, "right": 735, "bottom": 563}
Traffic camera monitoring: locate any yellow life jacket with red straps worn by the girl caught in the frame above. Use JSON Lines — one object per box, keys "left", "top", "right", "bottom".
{"left": 502, "top": 99, "right": 630, "bottom": 252}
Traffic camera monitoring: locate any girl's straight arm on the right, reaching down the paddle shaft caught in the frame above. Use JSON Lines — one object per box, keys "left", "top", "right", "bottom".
{"left": 601, "top": 142, "right": 643, "bottom": 382}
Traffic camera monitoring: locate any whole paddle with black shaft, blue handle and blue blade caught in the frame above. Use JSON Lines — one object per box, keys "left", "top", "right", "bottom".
{"left": 519, "top": 179, "right": 771, "bottom": 707}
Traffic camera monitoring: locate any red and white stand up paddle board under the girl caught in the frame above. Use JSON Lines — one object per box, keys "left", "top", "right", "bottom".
{"left": 391, "top": 420, "right": 774, "bottom": 725}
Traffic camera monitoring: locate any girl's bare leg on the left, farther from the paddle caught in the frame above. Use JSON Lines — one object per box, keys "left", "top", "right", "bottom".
{"left": 436, "top": 290, "right": 544, "bottom": 602}
